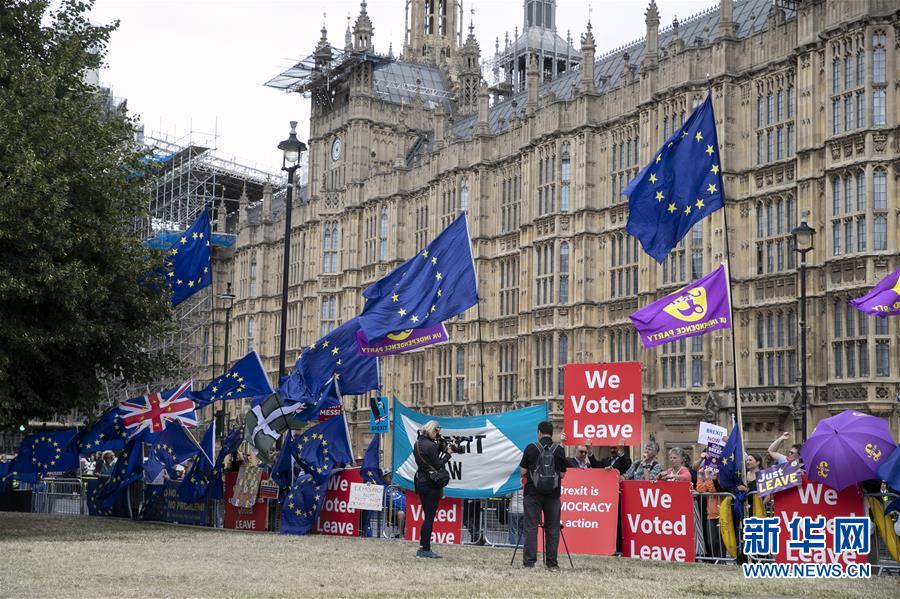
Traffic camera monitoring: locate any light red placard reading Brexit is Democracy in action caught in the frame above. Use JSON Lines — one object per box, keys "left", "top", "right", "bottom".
{"left": 538, "top": 469, "right": 619, "bottom": 555}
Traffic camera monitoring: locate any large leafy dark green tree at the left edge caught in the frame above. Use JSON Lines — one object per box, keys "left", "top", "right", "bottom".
{"left": 0, "top": 0, "right": 173, "bottom": 427}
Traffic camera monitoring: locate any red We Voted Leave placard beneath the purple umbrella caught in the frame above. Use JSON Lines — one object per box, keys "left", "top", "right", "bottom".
{"left": 775, "top": 477, "right": 869, "bottom": 565}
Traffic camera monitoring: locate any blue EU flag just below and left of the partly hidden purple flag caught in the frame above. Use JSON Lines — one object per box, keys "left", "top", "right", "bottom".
{"left": 278, "top": 318, "right": 379, "bottom": 413}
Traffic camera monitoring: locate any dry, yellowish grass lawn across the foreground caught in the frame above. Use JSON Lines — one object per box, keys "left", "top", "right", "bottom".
{"left": 0, "top": 512, "right": 900, "bottom": 599}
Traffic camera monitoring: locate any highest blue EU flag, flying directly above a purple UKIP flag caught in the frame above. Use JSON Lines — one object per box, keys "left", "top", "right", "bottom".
{"left": 622, "top": 95, "right": 725, "bottom": 262}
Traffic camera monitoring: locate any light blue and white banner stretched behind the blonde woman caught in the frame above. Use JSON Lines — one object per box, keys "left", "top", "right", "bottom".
{"left": 391, "top": 398, "right": 547, "bottom": 499}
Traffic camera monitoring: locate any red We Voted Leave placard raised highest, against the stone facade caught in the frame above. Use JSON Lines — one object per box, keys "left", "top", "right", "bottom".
{"left": 563, "top": 362, "right": 642, "bottom": 447}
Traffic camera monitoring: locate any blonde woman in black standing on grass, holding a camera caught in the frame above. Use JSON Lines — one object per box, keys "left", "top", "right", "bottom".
{"left": 413, "top": 420, "right": 456, "bottom": 559}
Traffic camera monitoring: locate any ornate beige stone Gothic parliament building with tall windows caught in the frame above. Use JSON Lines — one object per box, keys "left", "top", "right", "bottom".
{"left": 200, "top": 0, "right": 900, "bottom": 458}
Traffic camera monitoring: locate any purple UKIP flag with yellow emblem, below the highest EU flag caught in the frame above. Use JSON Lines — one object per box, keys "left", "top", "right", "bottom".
{"left": 630, "top": 264, "right": 731, "bottom": 347}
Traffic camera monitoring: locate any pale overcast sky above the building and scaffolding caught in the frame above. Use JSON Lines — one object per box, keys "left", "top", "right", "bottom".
{"left": 91, "top": 0, "right": 718, "bottom": 172}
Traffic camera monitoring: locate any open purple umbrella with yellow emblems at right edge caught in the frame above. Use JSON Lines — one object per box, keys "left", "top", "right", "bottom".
{"left": 800, "top": 410, "right": 897, "bottom": 491}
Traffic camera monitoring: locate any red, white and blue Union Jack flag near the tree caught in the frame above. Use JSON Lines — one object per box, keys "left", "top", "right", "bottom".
{"left": 119, "top": 380, "right": 197, "bottom": 439}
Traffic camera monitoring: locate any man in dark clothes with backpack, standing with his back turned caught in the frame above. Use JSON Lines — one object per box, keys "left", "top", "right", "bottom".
{"left": 519, "top": 421, "right": 567, "bottom": 570}
